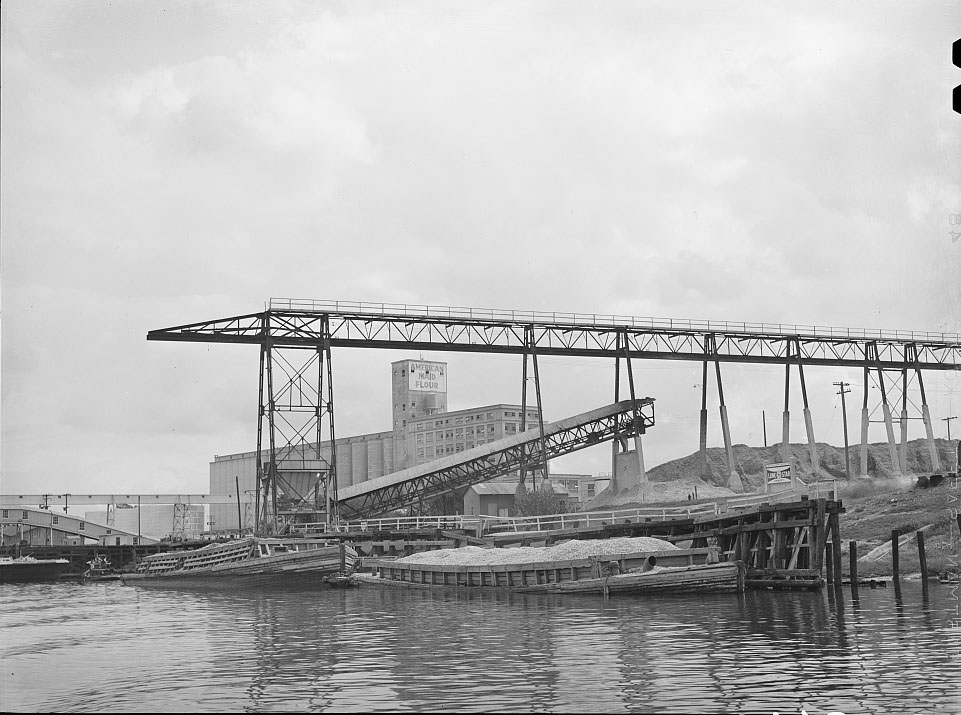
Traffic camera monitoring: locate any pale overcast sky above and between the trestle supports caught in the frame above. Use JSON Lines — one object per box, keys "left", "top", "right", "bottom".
{"left": 0, "top": 0, "right": 961, "bottom": 494}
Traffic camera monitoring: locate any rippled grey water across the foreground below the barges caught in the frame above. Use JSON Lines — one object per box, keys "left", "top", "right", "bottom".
{"left": 0, "top": 582, "right": 961, "bottom": 715}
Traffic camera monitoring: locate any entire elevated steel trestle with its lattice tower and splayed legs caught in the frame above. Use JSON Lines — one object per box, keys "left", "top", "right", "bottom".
{"left": 147, "top": 298, "right": 961, "bottom": 523}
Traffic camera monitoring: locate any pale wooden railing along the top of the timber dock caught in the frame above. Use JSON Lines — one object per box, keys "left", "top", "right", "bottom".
{"left": 291, "top": 480, "right": 838, "bottom": 535}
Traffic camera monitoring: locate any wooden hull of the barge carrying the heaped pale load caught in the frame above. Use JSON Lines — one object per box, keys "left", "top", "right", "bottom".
{"left": 355, "top": 549, "right": 745, "bottom": 594}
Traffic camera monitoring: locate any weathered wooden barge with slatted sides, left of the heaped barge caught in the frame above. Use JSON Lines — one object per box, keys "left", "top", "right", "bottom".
{"left": 121, "top": 536, "right": 357, "bottom": 588}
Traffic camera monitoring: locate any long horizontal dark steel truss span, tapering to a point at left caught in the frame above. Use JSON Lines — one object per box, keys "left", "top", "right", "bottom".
{"left": 147, "top": 310, "right": 961, "bottom": 370}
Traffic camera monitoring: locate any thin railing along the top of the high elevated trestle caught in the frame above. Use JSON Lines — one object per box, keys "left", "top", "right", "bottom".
{"left": 268, "top": 298, "right": 961, "bottom": 343}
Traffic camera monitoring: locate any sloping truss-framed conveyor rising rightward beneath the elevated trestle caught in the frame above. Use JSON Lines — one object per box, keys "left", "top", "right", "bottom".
{"left": 340, "top": 397, "right": 654, "bottom": 519}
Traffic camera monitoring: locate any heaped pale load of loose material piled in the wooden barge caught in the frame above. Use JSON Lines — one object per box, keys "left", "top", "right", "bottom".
{"left": 395, "top": 536, "right": 678, "bottom": 566}
